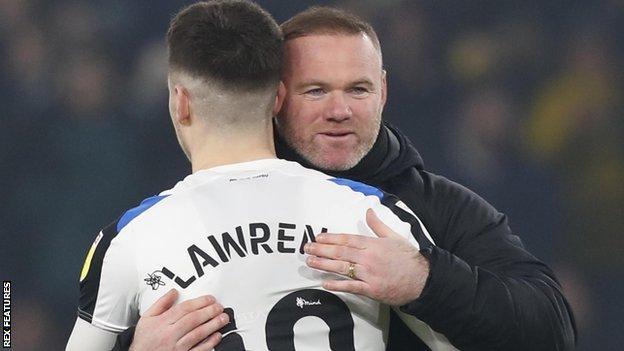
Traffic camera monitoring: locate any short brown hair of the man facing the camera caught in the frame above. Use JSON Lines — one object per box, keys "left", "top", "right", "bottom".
{"left": 280, "top": 6, "right": 381, "bottom": 55}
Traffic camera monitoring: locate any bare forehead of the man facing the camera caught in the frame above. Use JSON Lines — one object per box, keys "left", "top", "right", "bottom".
{"left": 285, "top": 34, "right": 381, "bottom": 83}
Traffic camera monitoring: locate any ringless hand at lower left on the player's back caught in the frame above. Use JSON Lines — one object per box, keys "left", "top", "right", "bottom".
{"left": 130, "top": 289, "right": 229, "bottom": 351}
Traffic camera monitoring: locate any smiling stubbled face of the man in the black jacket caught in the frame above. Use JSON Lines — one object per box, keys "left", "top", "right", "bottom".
{"left": 277, "top": 34, "right": 386, "bottom": 170}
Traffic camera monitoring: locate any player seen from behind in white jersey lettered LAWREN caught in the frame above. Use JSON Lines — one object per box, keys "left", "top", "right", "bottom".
{"left": 67, "top": 0, "right": 432, "bottom": 351}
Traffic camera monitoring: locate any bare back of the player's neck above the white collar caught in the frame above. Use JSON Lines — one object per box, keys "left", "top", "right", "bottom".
{"left": 191, "top": 129, "right": 276, "bottom": 173}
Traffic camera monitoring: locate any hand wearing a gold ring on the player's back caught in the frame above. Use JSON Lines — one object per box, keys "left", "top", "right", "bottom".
{"left": 305, "top": 209, "right": 429, "bottom": 306}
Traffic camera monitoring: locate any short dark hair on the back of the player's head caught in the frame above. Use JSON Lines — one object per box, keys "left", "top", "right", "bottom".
{"left": 167, "top": 0, "right": 283, "bottom": 93}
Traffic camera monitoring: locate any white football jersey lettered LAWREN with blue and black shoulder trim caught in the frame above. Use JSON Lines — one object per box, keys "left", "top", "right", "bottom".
{"left": 79, "top": 159, "right": 444, "bottom": 350}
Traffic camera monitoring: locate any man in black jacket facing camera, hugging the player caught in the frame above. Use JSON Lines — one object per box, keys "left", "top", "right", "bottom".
{"left": 116, "top": 4, "right": 576, "bottom": 350}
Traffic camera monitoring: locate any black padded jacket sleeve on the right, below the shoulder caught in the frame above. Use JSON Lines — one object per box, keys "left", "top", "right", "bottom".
{"left": 399, "top": 172, "right": 576, "bottom": 351}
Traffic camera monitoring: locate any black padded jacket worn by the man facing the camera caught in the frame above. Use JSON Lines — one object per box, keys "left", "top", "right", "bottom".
{"left": 116, "top": 125, "right": 576, "bottom": 351}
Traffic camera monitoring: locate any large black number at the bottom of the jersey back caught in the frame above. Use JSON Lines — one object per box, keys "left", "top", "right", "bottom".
{"left": 215, "top": 289, "right": 355, "bottom": 351}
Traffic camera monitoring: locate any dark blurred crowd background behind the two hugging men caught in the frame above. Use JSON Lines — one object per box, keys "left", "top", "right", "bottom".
{"left": 0, "top": 0, "right": 624, "bottom": 350}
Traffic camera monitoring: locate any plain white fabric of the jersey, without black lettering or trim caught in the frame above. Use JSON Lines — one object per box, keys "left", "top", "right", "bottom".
{"left": 78, "top": 159, "right": 450, "bottom": 350}
